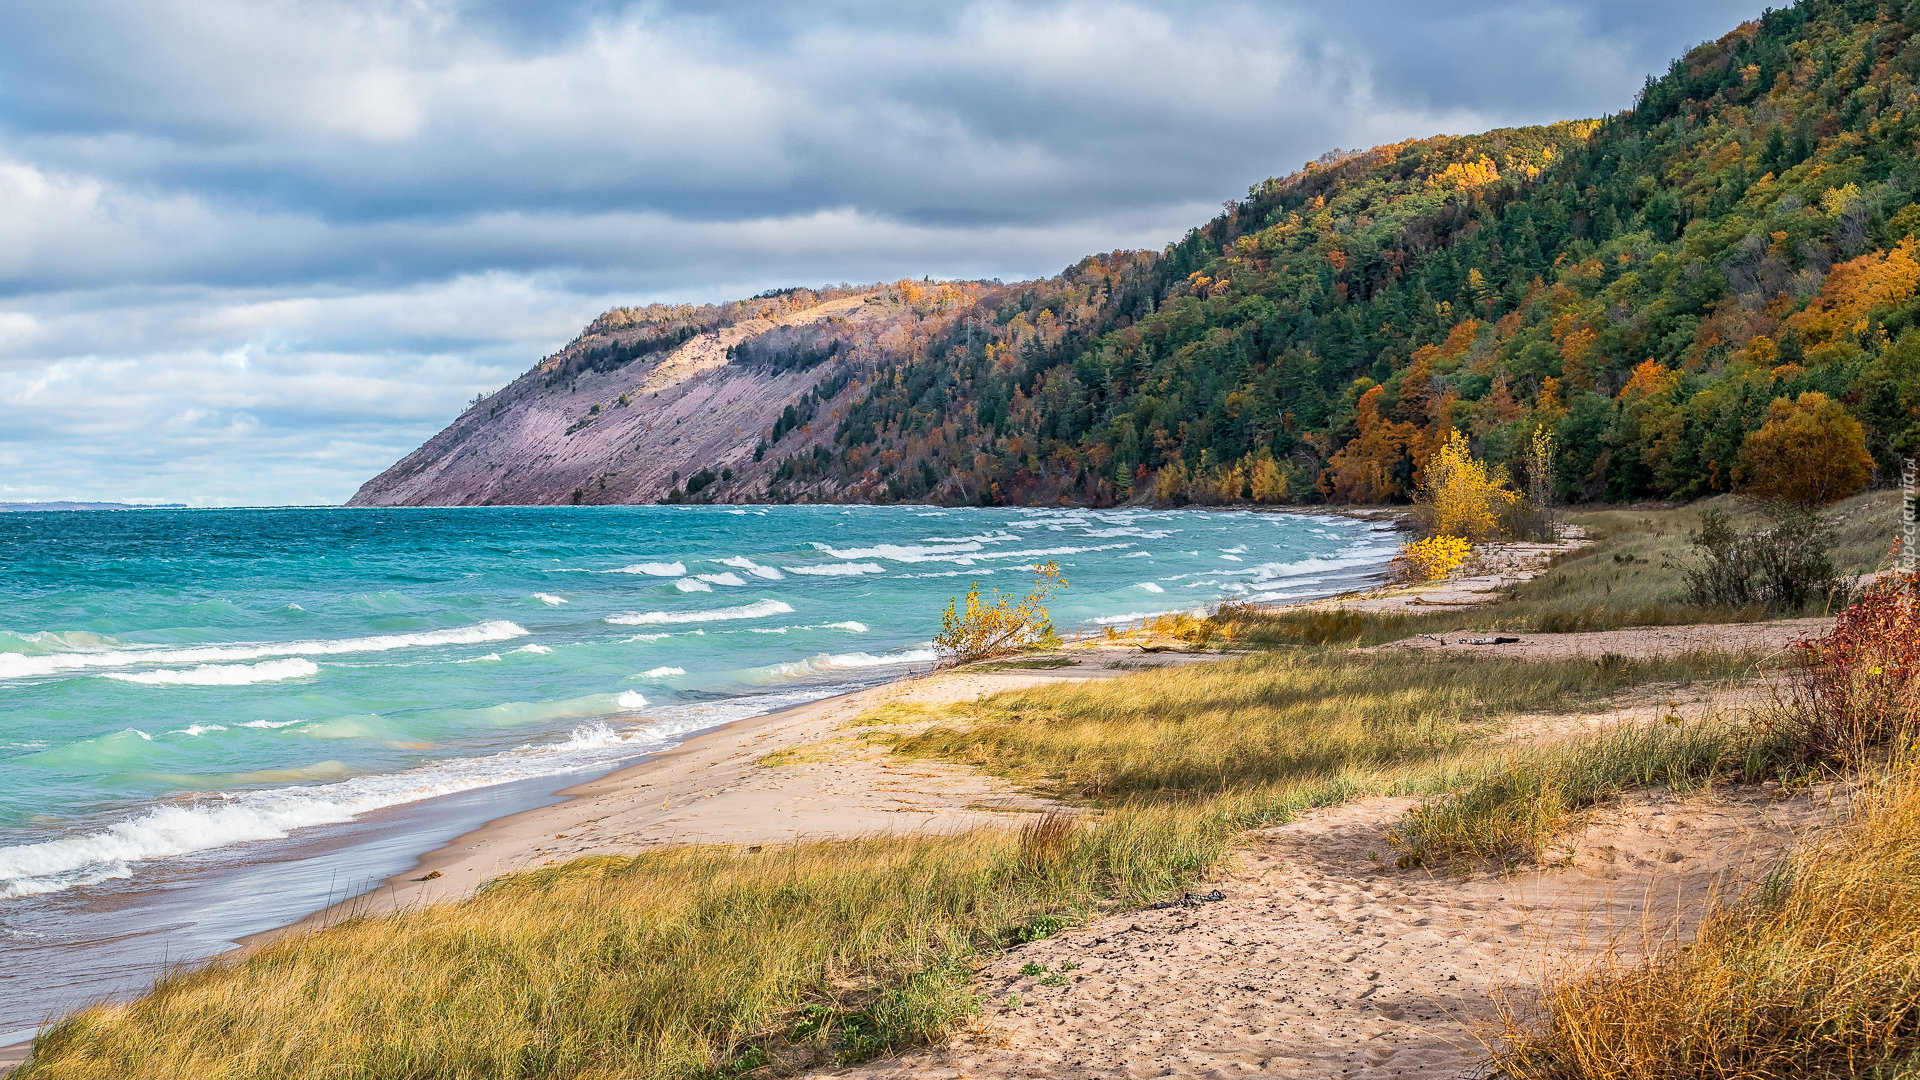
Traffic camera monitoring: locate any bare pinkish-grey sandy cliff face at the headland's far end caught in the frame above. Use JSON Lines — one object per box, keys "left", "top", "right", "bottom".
{"left": 348, "top": 282, "right": 991, "bottom": 505}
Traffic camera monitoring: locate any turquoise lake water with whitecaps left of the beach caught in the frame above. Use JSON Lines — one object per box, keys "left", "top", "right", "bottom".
{"left": 0, "top": 507, "right": 1392, "bottom": 1006}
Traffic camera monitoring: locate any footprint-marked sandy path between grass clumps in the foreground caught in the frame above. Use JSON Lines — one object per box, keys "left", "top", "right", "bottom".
{"left": 833, "top": 790, "right": 1830, "bottom": 1080}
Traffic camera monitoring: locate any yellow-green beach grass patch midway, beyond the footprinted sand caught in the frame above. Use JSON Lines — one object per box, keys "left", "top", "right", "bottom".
{"left": 879, "top": 650, "right": 1763, "bottom": 805}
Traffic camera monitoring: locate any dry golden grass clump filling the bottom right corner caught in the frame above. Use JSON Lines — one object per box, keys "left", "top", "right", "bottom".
{"left": 1500, "top": 761, "right": 1920, "bottom": 1080}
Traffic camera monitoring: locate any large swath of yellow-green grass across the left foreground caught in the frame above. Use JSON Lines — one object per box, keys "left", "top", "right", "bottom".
{"left": 17, "top": 809, "right": 1235, "bottom": 1080}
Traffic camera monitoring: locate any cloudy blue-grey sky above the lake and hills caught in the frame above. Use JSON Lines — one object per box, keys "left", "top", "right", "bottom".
{"left": 0, "top": 0, "right": 1761, "bottom": 505}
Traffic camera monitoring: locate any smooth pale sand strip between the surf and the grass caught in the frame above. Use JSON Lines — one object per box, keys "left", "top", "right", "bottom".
{"left": 240, "top": 644, "right": 1235, "bottom": 937}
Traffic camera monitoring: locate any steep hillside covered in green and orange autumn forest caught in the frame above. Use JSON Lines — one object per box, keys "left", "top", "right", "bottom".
{"left": 357, "top": 0, "right": 1920, "bottom": 505}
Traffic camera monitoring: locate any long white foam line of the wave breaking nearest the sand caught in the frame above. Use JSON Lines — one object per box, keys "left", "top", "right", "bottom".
{"left": 0, "top": 714, "right": 708, "bottom": 899}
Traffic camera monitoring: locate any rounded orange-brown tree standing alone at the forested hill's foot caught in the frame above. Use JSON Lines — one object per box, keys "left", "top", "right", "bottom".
{"left": 1734, "top": 390, "right": 1874, "bottom": 507}
